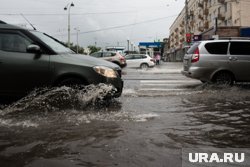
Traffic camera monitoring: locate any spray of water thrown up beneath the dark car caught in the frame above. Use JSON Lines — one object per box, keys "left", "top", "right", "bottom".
{"left": 0, "top": 84, "right": 114, "bottom": 115}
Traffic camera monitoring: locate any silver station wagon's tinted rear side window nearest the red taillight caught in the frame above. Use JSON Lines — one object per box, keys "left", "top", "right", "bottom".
{"left": 205, "top": 42, "right": 228, "bottom": 54}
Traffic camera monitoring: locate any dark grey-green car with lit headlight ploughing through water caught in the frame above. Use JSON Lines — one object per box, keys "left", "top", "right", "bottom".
{"left": 0, "top": 22, "right": 123, "bottom": 97}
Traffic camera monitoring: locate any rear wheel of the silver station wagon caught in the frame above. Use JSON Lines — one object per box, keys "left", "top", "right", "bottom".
{"left": 214, "top": 72, "right": 234, "bottom": 85}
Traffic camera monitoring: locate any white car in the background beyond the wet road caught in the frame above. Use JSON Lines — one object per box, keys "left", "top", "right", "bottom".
{"left": 125, "top": 54, "right": 155, "bottom": 69}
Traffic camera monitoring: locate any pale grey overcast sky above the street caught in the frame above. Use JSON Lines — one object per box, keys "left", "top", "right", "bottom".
{"left": 0, "top": 0, "right": 185, "bottom": 47}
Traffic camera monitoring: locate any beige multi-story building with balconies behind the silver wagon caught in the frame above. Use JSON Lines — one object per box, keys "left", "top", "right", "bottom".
{"left": 168, "top": 0, "right": 250, "bottom": 61}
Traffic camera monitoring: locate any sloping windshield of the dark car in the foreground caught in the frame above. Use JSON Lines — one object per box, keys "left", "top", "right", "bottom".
{"left": 31, "top": 31, "right": 74, "bottom": 53}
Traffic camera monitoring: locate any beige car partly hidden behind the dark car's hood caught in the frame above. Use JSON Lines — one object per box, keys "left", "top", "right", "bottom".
{"left": 90, "top": 51, "right": 127, "bottom": 68}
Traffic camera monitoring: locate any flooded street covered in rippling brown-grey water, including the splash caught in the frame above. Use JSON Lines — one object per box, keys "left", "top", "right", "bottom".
{"left": 0, "top": 63, "right": 250, "bottom": 167}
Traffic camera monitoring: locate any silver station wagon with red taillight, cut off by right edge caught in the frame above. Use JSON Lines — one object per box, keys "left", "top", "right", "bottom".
{"left": 182, "top": 38, "right": 250, "bottom": 85}
